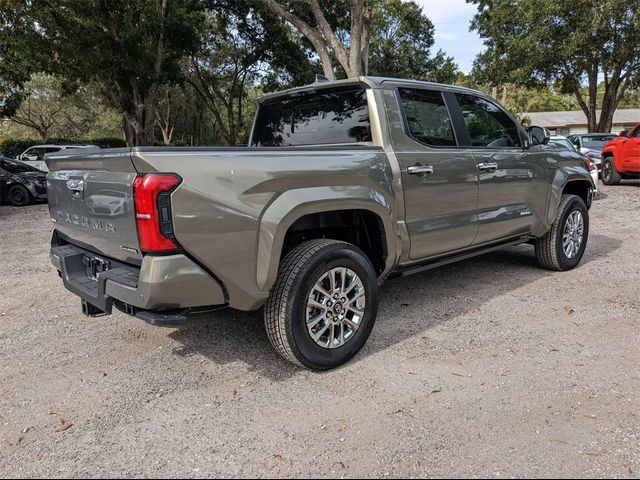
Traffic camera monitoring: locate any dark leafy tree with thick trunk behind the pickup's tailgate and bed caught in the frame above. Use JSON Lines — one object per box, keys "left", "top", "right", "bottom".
{"left": 12, "top": 0, "right": 203, "bottom": 145}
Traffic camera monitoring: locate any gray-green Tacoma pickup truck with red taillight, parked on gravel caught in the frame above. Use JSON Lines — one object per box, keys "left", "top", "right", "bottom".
{"left": 47, "top": 77, "right": 593, "bottom": 370}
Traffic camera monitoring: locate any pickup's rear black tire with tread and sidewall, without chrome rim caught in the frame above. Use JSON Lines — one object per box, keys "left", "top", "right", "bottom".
{"left": 264, "top": 240, "right": 378, "bottom": 370}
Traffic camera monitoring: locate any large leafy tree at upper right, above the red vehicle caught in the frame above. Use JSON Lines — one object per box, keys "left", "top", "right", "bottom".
{"left": 467, "top": 0, "right": 640, "bottom": 132}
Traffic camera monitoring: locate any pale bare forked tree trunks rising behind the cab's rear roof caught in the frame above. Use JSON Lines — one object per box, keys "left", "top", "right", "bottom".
{"left": 260, "top": 0, "right": 371, "bottom": 80}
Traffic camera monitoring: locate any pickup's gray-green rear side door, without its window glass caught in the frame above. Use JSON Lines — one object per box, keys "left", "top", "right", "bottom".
{"left": 385, "top": 90, "right": 478, "bottom": 260}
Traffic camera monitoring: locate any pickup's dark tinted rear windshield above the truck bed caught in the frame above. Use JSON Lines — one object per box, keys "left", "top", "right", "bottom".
{"left": 251, "top": 86, "right": 371, "bottom": 147}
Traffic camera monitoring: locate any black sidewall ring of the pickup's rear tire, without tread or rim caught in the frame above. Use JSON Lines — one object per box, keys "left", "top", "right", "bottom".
{"left": 287, "top": 244, "right": 378, "bottom": 370}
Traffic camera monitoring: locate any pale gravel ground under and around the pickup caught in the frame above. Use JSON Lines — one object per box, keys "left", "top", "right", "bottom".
{"left": 0, "top": 184, "right": 640, "bottom": 478}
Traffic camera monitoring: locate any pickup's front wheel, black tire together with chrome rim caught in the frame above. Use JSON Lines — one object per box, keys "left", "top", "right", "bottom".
{"left": 534, "top": 195, "right": 589, "bottom": 271}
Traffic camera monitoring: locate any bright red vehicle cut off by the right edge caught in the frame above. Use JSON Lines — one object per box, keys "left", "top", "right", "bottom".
{"left": 602, "top": 123, "right": 640, "bottom": 185}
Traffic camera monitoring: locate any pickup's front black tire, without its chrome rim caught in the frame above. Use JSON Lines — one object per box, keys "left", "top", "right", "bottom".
{"left": 534, "top": 195, "right": 589, "bottom": 272}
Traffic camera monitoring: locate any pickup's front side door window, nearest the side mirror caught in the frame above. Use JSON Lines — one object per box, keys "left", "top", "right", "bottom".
{"left": 456, "top": 93, "right": 522, "bottom": 147}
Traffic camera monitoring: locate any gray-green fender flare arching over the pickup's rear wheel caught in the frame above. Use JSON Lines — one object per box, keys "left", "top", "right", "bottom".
{"left": 256, "top": 186, "right": 397, "bottom": 292}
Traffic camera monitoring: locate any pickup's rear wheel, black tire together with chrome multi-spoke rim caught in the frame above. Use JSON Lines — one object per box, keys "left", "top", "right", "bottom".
{"left": 264, "top": 240, "right": 378, "bottom": 370}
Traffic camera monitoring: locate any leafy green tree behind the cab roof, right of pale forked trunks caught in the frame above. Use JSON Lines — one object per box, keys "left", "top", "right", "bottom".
{"left": 369, "top": 0, "right": 458, "bottom": 83}
